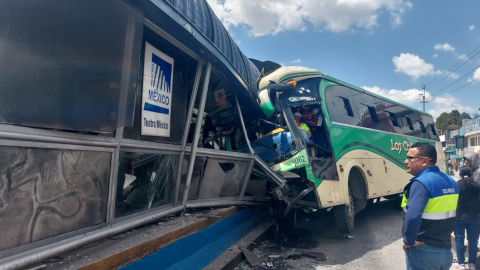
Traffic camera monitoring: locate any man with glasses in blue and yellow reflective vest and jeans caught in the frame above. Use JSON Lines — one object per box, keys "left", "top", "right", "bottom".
{"left": 402, "top": 143, "right": 459, "bottom": 270}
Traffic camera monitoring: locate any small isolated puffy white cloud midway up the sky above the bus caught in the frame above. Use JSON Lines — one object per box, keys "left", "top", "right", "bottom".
{"left": 392, "top": 53, "right": 442, "bottom": 80}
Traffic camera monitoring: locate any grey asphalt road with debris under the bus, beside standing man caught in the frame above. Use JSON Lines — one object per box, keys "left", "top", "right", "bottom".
{"left": 253, "top": 200, "right": 405, "bottom": 270}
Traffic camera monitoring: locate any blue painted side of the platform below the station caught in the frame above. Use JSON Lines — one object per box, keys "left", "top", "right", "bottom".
{"left": 120, "top": 207, "right": 271, "bottom": 270}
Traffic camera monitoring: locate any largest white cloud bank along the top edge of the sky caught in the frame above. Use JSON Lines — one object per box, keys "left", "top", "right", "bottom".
{"left": 207, "top": 0, "right": 413, "bottom": 36}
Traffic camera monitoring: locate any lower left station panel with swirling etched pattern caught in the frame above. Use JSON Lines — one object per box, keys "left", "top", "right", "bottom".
{"left": 0, "top": 146, "right": 111, "bottom": 251}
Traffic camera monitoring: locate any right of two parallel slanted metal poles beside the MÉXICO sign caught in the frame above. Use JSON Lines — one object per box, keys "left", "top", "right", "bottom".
{"left": 182, "top": 62, "right": 212, "bottom": 205}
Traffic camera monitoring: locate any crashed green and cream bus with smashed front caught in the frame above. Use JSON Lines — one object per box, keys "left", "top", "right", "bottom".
{"left": 251, "top": 67, "right": 446, "bottom": 233}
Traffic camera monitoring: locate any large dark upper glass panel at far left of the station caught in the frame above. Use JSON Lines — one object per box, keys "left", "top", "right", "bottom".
{"left": 0, "top": 0, "right": 143, "bottom": 133}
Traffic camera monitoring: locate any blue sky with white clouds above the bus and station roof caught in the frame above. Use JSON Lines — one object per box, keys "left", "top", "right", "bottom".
{"left": 207, "top": 0, "right": 480, "bottom": 118}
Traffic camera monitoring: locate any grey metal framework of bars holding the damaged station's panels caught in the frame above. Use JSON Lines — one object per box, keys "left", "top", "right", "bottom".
{"left": 0, "top": 0, "right": 265, "bottom": 270}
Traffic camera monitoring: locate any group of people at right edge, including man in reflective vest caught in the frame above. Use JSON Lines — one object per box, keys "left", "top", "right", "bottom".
{"left": 402, "top": 146, "right": 480, "bottom": 270}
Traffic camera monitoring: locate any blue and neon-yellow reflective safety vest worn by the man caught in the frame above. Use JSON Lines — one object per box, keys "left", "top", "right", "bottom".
{"left": 401, "top": 166, "right": 459, "bottom": 248}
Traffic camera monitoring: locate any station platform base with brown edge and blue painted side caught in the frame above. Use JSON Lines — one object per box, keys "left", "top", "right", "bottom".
{"left": 33, "top": 207, "right": 271, "bottom": 270}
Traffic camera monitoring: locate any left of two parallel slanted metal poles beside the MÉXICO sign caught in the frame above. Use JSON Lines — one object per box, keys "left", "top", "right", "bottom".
{"left": 173, "top": 61, "right": 204, "bottom": 205}
